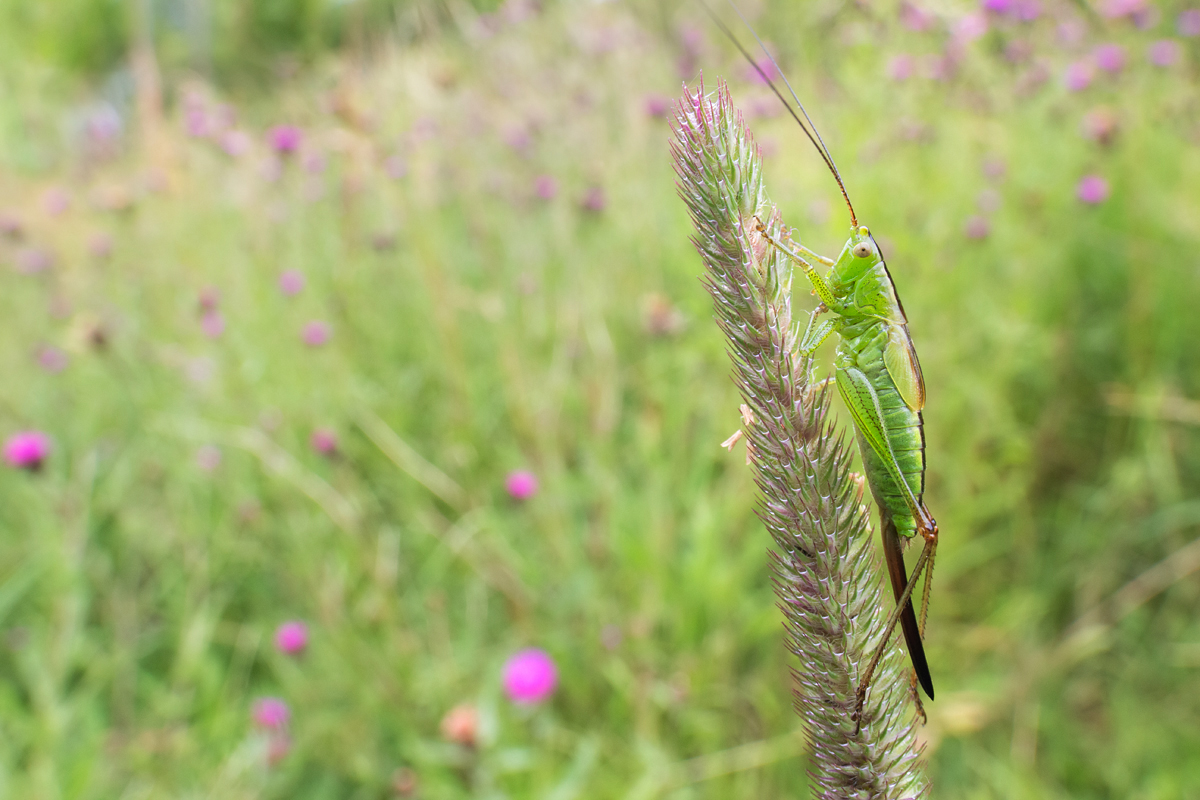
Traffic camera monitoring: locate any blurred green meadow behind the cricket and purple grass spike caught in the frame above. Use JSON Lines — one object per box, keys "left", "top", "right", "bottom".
{"left": 0, "top": 0, "right": 1200, "bottom": 800}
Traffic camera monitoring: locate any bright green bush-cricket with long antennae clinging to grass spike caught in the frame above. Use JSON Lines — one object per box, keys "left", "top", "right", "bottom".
{"left": 702, "top": 0, "right": 937, "bottom": 724}
